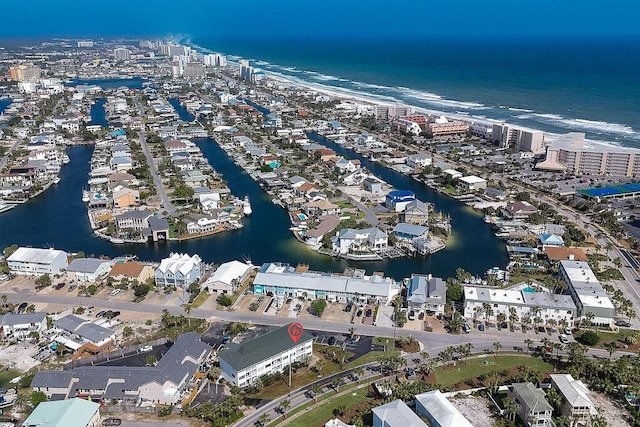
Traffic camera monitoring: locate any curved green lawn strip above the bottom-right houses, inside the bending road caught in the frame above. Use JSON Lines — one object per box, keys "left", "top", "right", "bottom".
{"left": 435, "top": 356, "right": 553, "bottom": 387}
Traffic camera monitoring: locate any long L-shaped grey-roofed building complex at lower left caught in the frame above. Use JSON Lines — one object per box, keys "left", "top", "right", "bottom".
{"left": 31, "top": 332, "right": 211, "bottom": 405}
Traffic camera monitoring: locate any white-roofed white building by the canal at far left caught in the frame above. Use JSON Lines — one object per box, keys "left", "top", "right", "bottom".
{"left": 7, "top": 248, "right": 69, "bottom": 276}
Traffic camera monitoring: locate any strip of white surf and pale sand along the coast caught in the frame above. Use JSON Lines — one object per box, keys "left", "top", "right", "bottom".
{"left": 181, "top": 38, "right": 640, "bottom": 149}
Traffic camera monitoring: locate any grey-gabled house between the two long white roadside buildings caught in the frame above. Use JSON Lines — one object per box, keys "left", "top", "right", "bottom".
{"left": 407, "top": 274, "right": 447, "bottom": 314}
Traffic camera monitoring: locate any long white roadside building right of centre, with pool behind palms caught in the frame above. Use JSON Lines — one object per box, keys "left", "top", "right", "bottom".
{"left": 464, "top": 286, "right": 578, "bottom": 326}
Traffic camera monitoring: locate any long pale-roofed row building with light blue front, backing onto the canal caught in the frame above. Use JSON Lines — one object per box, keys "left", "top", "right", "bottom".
{"left": 253, "top": 263, "right": 400, "bottom": 304}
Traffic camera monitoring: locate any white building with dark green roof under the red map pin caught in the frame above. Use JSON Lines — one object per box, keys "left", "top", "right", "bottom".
{"left": 218, "top": 323, "right": 313, "bottom": 387}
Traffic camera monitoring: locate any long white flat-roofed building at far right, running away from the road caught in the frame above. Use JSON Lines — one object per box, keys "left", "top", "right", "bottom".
{"left": 559, "top": 261, "right": 616, "bottom": 325}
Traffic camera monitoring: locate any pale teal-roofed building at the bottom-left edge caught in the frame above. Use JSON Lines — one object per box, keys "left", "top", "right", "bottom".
{"left": 22, "top": 397, "right": 100, "bottom": 427}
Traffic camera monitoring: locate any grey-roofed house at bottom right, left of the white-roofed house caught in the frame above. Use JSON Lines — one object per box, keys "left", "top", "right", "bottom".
{"left": 507, "top": 382, "right": 554, "bottom": 427}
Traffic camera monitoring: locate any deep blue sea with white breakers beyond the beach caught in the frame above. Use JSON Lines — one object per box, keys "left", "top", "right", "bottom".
{"left": 190, "top": 37, "right": 640, "bottom": 148}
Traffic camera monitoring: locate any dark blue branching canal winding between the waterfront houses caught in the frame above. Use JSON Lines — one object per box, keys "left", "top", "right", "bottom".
{"left": 0, "top": 96, "right": 507, "bottom": 279}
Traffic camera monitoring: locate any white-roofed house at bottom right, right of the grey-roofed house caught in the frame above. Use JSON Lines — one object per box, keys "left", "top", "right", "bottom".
{"left": 550, "top": 374, "right": 598, "bottom": 425}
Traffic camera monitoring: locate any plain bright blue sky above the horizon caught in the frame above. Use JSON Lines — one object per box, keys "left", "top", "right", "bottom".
{"left": 0, "top": 0, "right": 640, "bottom": 38}
